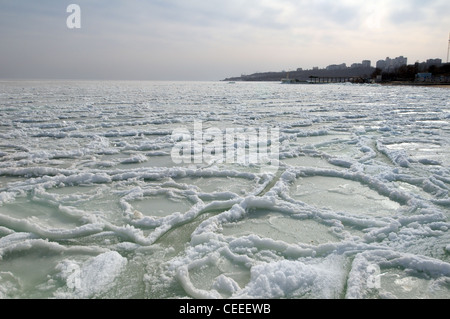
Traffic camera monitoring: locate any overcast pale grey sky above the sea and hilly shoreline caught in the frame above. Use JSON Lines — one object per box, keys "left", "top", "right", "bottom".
{"left": 0, "top": 0, "right": 450, "bottom": 80}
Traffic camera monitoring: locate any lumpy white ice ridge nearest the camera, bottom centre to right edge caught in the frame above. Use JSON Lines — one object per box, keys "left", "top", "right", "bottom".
{"left": 171, "top": 229, "right": 450, "bottom": 299}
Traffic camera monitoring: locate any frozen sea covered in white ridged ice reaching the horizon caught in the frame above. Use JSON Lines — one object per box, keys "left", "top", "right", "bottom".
{"left": 0, "top": 81, "right": 450, "bottom": 299}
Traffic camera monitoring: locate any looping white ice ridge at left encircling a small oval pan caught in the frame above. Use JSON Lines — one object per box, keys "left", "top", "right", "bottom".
{"left": 0, "top": 168, "right": 271, "bottom": 245}
